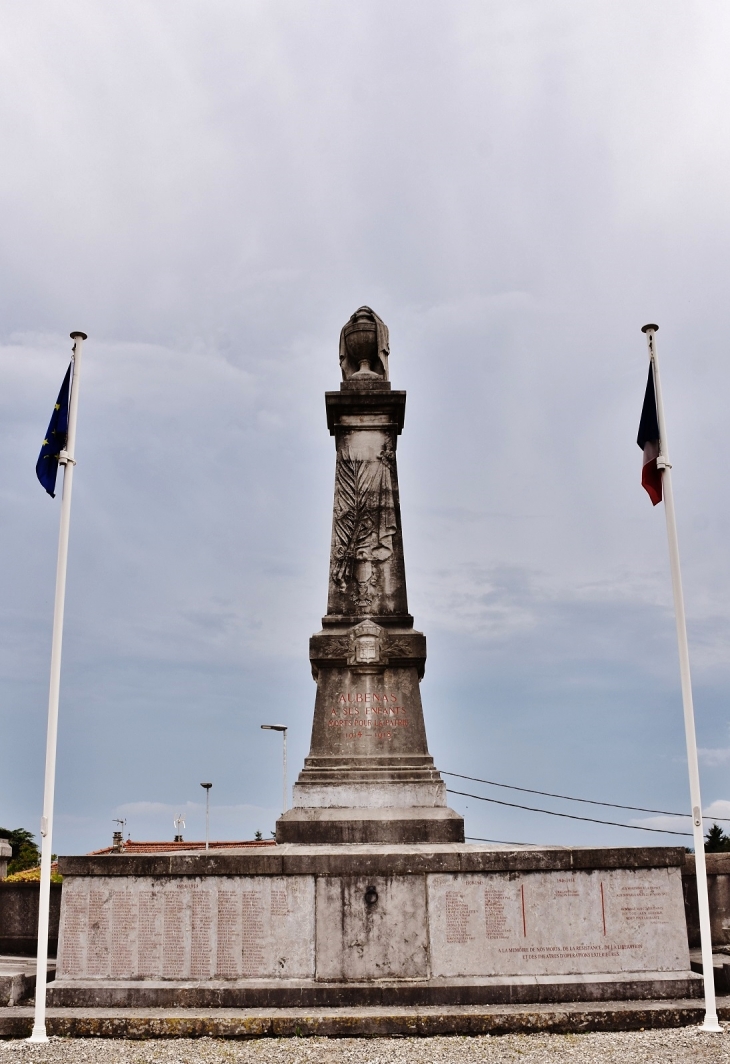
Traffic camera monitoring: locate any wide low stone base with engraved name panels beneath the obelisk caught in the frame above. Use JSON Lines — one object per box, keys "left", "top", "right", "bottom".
{"left": 48, "top": 844, "right": 701, "bottom": 1008}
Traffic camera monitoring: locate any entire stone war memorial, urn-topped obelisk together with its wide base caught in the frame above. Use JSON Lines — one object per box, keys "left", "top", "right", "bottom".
{"left": 48, "top": 306, "right": 701, "bottom": 1008}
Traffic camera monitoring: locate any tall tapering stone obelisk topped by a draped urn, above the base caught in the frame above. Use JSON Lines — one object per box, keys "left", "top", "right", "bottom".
{"left": 277, "top": 306, "right": 464, "bottom": 843}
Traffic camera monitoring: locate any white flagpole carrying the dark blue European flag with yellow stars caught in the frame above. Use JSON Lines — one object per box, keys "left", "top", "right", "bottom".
{"left": 27, "top": 332, "right": 86, "bottom": 1042}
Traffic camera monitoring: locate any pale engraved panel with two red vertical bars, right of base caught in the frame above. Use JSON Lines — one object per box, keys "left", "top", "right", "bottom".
{"left": 428, "top": 868, "right": 688, "bottom": 978}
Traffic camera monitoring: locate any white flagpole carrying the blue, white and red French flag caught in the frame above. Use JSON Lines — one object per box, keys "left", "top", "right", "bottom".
{"left": 642, "top": 326, "right": 723, "bottom": 1031}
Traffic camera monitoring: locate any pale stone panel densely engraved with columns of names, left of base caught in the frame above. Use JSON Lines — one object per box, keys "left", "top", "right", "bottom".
{"left": 59, "top": 876, "right": 314, "bottom": 981}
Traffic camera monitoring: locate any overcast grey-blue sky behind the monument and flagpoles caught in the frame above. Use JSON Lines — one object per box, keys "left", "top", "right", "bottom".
{"left": 0, "top": 0, "right": 730, "bottom": 853}
